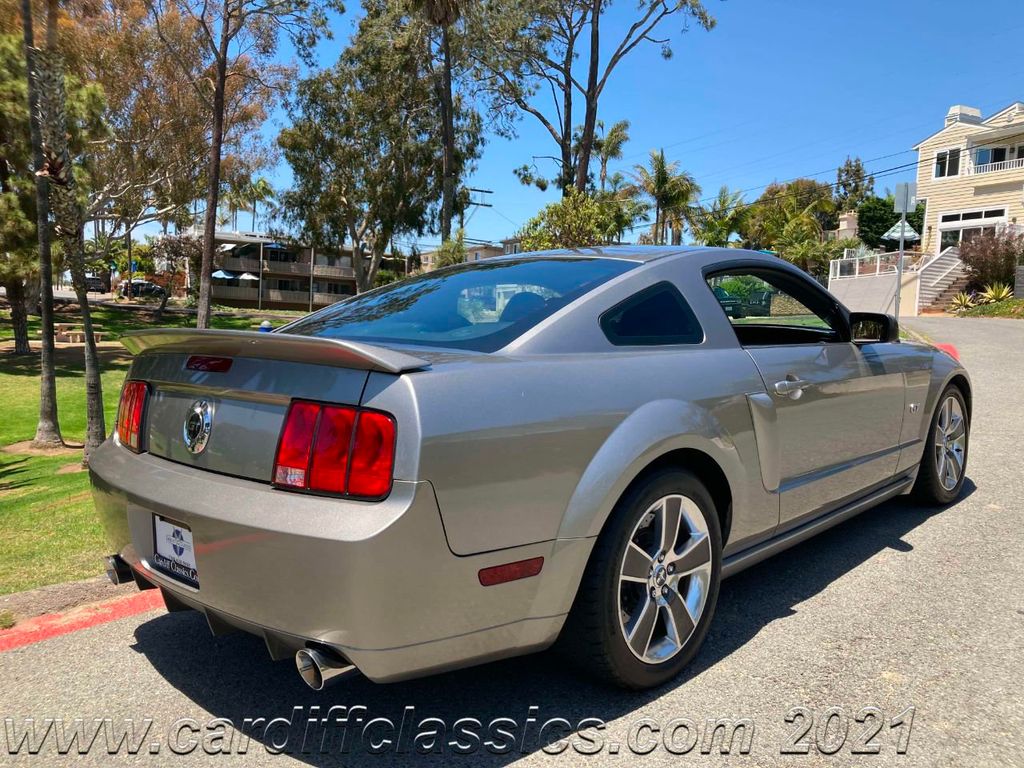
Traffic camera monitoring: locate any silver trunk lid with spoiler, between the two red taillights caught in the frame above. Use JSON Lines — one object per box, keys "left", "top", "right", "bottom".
{"left": 122, "top": 330, "right": 430, "bottom": 482}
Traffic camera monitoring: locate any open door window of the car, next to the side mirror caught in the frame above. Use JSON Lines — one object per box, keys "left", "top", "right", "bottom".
{"left": 707, "top": 268, "right": 840, "bottom": 346}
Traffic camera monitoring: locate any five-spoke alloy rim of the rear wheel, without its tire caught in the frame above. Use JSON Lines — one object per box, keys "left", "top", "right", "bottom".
{"left": 618, "top": 495, "right": 712, "bottom": 664}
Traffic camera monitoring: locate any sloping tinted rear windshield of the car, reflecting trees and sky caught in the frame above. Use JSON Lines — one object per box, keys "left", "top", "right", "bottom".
{"left": 282, "top": 257, "right": 637, "bottom": 352}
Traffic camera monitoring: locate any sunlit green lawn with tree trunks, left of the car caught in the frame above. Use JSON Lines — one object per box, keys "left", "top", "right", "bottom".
{"left": 0, "top": 307, "right": 299, "bottom": 594}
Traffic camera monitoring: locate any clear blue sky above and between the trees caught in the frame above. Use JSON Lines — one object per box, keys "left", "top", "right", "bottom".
{"left": 267, "top": 0, "right": 1024, "bottom": 250}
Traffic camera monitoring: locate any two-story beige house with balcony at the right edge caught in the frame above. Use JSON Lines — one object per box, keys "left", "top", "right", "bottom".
{"left": 913, "top": 101, "right": 1024, "bottom": 254}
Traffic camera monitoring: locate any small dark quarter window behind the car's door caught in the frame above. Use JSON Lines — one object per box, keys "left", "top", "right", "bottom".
{"left": 601, "top": 283, "right": 703, "bottom": 346}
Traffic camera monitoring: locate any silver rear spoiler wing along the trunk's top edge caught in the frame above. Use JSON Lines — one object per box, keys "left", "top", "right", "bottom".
{"left": 121, "top": 328, "right": 430, "bottom": 374}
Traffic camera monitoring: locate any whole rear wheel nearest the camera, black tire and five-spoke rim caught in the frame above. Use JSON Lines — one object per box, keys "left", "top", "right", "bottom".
{"left": 560, "top": 470, "right": 722, "bottom": 688}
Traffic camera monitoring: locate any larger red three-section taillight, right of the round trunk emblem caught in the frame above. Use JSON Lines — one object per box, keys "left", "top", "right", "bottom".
{"left": 273, "top": 400, "right": 395, "bottom": 499}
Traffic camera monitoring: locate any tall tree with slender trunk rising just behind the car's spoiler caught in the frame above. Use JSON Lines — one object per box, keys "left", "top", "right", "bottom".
{"left": 146, "top": 0, "right": 344, "bottom": 328}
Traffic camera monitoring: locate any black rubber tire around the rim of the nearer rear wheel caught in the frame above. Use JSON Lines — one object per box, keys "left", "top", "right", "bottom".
{"left": 558, "top": 469, "right": 722, "bottom": 690}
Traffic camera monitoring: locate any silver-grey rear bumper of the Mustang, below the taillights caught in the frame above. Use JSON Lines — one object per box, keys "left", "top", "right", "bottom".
{"left": 90, "top": 441, "right": 593, "bottom": 682}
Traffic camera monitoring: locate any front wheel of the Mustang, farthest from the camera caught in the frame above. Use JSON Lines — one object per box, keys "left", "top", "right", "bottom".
{"left": 913, "top": 385, "right": 971, "bottom": 505}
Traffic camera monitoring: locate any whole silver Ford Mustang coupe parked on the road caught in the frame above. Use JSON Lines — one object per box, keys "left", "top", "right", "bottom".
{"left": 90, "top": 246, "right": 972, "bottom": 688}
